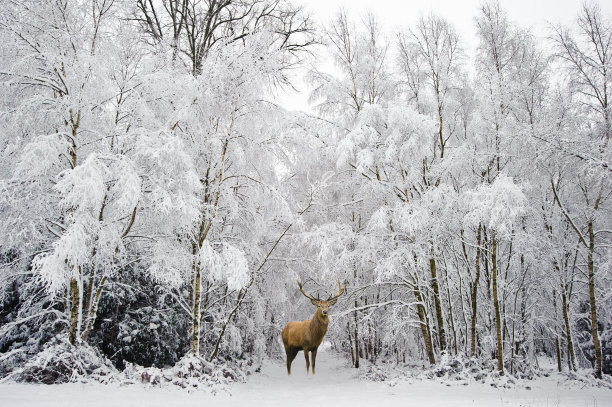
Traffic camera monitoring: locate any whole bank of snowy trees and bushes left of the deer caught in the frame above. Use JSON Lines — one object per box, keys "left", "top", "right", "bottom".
{"left": 0, "top": 0, "right": 316, "bottom": 373}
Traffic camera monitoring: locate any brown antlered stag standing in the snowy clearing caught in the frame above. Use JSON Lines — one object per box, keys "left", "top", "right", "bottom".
{"left": 282, "top": 281, "right": 346, "bottom": 375}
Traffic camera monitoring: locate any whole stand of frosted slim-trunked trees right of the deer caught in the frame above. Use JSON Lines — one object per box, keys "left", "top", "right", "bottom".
{"left": 302, "top": 2, "right": 612, "bottom": 377}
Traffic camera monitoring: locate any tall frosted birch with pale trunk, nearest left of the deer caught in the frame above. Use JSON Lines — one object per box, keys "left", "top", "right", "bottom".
{"left": 131, "top": 15, "right": 316, "bottom": 358}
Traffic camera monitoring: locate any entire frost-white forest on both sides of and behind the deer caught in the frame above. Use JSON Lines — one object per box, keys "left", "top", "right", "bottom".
{"left": 0, "top": 0, "right": 612, "bottom": 404}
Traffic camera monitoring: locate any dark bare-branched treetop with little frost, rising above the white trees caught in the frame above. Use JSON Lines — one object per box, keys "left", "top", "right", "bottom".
{"left": 133, "top": 0, "right": 315, "bottom": 76}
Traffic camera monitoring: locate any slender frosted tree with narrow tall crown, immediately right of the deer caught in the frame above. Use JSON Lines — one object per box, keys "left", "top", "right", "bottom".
{"left": 310, "top": 11, "right": 394, "bottom": 367}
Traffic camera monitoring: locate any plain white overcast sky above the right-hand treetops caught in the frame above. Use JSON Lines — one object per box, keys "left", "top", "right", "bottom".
{"left": 281, "top": 0, "right": 612, "bottom": 110}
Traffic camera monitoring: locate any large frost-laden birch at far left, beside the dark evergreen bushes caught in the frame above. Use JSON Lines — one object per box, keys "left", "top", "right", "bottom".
{"left": 3, "top": 2, "right": 197, "bottom": 345}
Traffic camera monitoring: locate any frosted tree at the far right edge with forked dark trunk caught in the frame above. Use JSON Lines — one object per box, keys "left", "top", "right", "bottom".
{"left": 551, "top": 3, "right": 612, "bottom": 378}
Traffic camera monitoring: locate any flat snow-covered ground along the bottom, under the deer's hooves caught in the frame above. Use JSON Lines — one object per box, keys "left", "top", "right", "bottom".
{"left": 0, "top": 349, "right": 612, "bottom": 407}
